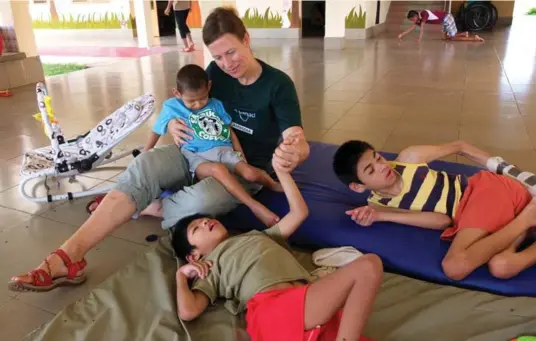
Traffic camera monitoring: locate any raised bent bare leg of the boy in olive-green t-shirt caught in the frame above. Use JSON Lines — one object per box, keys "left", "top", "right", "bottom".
{"left": 304, "top": 254, "right": 383, "bottom": 341}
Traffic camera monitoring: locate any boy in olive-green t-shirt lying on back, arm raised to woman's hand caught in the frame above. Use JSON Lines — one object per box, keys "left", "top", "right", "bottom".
{"left": 172, "top": 135, "right": 383, "bottom": 341}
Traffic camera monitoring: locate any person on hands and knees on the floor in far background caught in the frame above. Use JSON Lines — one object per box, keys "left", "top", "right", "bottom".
{"left": 398, "top": 9, "right": 484, "bottom": 42}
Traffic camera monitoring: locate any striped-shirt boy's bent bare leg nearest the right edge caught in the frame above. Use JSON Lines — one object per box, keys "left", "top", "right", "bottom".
{"left": 489, "top": 235, "right": 536, "bottom": 279}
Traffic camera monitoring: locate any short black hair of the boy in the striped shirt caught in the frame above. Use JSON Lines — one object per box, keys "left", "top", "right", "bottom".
{"left": 333, "top": 140, "right": 374, "bottom": 185}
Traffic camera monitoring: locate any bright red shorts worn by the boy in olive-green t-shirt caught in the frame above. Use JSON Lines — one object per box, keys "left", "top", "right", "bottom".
{"left": 246, "top": 285, "right": 372, "bottom": 341}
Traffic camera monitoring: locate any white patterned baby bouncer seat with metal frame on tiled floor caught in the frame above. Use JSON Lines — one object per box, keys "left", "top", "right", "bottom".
{"left": 19, "top": 83, "right": 154, "bottom": 203}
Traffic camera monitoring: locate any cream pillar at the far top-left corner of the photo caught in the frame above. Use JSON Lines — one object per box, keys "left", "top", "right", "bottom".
{"left": 9, "top": 0, "right": 38, "bottom": 57}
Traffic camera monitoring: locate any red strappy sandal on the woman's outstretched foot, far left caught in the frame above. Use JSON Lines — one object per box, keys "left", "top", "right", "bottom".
{"left": 8, "top": 249, "right": 87, "bottom": 291}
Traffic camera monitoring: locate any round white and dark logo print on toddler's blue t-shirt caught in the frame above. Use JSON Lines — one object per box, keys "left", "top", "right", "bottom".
{"left": 189, "top": 109, "right": 231, "bottom": 141}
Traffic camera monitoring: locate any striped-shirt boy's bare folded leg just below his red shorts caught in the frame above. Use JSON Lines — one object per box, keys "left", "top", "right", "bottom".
{"left": 442, "top": 199, "right": 536, "bottom": 281}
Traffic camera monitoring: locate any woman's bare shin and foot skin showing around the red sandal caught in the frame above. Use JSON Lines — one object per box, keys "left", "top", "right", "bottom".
{"left": 12, "top": 190, "right": 136, "bottom": 283}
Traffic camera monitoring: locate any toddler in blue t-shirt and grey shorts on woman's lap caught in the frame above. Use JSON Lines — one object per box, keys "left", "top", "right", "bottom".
{"left": 145, "top": 64, "right": 281, "bottom": 226}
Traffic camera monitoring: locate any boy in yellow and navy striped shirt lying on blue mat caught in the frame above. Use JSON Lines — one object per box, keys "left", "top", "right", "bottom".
{"left": 333, "top": 140, "right": 536, "bottom": 281}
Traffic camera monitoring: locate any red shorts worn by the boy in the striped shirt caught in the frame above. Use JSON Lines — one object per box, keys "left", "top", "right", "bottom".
{"left": 441, "top": 171, "right": 532, "bottom": 239}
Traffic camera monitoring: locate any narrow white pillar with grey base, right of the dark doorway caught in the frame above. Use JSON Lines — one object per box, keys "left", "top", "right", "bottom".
{"left": 324, "top": 0, "right": 346, "bottom": 50}
